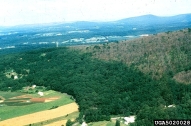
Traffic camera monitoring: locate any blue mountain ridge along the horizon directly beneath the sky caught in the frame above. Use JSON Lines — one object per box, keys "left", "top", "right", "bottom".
{"left": 0, "top": 13, "right": 191, "bottom": 29}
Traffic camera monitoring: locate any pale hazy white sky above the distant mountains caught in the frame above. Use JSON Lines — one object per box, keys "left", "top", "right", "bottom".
{"left": 0, "top": 0, "right": 191, "bottom": 26}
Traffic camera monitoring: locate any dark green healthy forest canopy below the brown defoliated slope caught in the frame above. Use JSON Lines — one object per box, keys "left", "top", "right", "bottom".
{"left": 0, "top": 28, "right": 191, "bottom": 126}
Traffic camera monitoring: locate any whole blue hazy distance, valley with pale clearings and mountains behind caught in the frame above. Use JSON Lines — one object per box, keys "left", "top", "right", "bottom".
{"left": 0, "top": 14, "right": 191, "bottom": 53}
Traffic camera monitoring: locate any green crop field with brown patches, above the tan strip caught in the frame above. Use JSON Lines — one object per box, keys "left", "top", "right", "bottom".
{"left": 0, "top": 90, "right": 74, "bottom": 120}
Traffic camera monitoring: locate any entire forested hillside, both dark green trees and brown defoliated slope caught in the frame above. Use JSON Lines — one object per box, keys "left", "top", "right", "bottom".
{"left": 0, "top": 29, "right": 191, "bottom": 126}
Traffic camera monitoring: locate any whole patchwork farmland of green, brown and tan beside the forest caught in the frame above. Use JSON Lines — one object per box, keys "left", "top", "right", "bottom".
{"left": 0, "top": 90, "right": 78, "bottom": 125}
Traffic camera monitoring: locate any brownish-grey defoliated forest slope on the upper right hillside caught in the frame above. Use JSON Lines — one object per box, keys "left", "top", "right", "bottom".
{"left": 80, "top": 28, "right": 191, "bottom": 82}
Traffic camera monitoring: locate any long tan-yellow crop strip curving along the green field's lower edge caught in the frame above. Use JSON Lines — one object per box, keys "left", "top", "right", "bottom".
{"left": 0, "top": 103, "right": 78, "bottom": 126}
